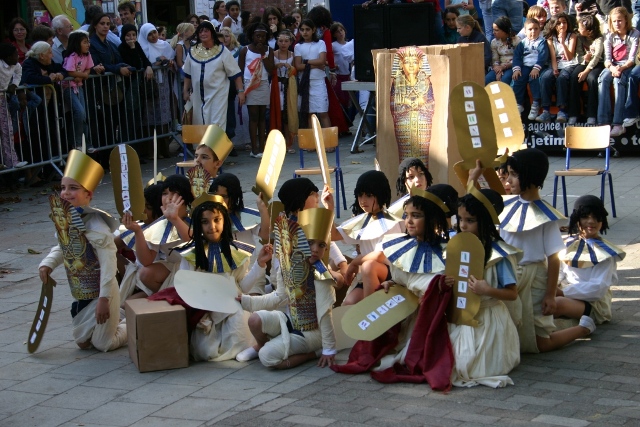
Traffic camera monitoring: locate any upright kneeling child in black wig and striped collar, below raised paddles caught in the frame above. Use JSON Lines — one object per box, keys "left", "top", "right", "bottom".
{"left": 500, "top": 148, "right": 595, "bottom": 353}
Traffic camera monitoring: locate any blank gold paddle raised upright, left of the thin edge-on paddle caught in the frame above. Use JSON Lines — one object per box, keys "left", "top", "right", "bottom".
{"left": 251, "top": 129, "right": 287, "bottom": 203}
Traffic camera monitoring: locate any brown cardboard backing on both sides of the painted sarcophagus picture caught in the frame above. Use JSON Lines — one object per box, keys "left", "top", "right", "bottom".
{"left": 372, "top": 43, "right": 484, "bottom": 200}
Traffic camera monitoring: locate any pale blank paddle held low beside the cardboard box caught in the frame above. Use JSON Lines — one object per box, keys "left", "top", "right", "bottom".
{"left": 174, "top": 270, "right": 240, "bottom": 313}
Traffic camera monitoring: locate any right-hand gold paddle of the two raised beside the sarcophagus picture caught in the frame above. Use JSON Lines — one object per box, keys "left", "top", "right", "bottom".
{"left": 484, "top": 82, "right": 524, "bottom": 154}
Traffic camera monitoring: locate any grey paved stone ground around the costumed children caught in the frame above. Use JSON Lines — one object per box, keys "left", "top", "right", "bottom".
{"left": 0, "top": 131, "right": 640, "bottom": 427}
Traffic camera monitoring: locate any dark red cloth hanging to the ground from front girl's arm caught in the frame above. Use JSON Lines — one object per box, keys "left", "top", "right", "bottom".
{"left": 331, "top": 275, "right": 455, "bottom": 391}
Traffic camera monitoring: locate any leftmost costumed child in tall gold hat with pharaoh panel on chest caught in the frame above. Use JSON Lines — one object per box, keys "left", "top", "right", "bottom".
{"left": 39, "top": 150, "right": 127, "bottom": 351}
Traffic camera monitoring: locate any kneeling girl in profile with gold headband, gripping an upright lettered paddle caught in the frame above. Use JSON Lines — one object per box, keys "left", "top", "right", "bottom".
{"left": 449, "top": 184, "right": 521, "bottom": 388}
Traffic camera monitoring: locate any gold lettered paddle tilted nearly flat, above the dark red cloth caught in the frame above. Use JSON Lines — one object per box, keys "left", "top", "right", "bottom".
{"left": 342, "top": 285, "right": 418, "bottom": 341}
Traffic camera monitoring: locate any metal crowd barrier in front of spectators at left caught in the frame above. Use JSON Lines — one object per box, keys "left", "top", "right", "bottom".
{"left": 0, "top": 67, "right": 183, "bottom": 174}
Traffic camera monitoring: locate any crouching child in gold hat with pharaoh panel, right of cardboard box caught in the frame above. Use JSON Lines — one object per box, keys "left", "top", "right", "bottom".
{"left": 237, "top": 208, "right": 337, "bottom": 369}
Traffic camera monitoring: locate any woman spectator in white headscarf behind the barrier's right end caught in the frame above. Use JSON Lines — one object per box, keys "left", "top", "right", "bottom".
{"left": 138, "top": 24, "right": 176, "bottom": 133}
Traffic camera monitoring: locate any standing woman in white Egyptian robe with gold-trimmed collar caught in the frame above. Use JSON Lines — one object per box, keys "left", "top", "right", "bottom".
{"left": 182, "top": 21, "right": 245, "bottom": 129}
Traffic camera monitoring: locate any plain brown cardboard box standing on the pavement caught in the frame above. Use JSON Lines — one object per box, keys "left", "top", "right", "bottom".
{"left": 124, "top": 298, "right": 189, "bottom": 372}
